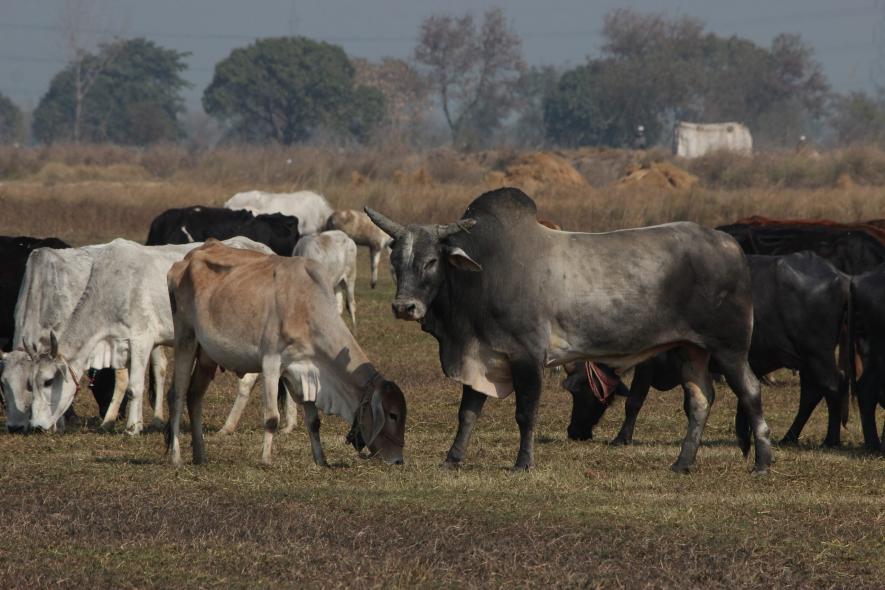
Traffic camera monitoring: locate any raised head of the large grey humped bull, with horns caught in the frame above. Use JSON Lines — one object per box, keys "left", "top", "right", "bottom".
{"left": 366, "top": 207, "right": 482, "bottom": 321}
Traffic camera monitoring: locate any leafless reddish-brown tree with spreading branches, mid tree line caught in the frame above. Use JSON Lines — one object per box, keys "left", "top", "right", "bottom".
{"left": 415, "top": 8, "right": 525, "bottom": 147}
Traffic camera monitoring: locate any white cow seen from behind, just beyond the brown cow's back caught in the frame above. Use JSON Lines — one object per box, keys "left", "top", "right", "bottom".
{"left": 292, "top": 230, "right": 356, "bottom": 334}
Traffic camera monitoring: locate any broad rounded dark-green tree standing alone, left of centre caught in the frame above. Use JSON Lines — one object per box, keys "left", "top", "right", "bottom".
{"left": 203, "top": 37, "right": 384, "bottom": 145}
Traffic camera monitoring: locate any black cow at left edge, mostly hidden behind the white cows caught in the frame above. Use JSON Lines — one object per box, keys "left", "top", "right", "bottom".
{"left": 0, "top": 236, "right": 119, "bottom": 430}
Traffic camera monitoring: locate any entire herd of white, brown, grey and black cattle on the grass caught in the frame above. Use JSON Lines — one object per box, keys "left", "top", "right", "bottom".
{"left": 0, "top": 188, "right": 885, "bottom": 473}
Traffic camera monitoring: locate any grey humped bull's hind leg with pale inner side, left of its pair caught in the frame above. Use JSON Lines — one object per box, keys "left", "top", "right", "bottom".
{"left": 670, "top": 346, "right": 716, "bottom": 473}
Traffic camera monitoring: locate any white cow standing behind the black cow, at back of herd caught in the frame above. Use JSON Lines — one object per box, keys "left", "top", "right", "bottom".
{"left": 224, "top": 191, "right": 332, "bottom": 236}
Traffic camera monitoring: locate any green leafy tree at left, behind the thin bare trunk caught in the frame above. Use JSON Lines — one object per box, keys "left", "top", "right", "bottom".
{"left": 33, "top": 38, "right": 187, "bottom": 145}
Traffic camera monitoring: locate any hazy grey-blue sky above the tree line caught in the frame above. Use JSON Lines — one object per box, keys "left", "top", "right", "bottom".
{"left": 0, "top": 0, "right": 885, "bottom": 109}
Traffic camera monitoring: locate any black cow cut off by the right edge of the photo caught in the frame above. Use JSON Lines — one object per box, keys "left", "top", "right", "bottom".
{"left": 851, "top": 266, "right": 885, "bottom": 452}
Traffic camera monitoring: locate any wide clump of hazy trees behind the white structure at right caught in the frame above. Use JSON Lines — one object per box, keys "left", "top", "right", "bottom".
{"left": 544, "top": 9, "right": 829, "bottom": 146}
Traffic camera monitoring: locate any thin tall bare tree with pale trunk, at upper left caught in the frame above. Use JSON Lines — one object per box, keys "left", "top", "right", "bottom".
{"left": 61, "top": 0, "right": 123, "bottom": 143}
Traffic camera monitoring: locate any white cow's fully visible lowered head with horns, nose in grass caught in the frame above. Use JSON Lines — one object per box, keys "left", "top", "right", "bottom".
{"left": 29, "top": 334, "right": 78, "bottom": 430}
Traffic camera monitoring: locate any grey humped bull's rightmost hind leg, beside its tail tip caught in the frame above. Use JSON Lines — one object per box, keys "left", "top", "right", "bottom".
{"left": 714, "top": 353, "right": 771, "bottom": 474}
